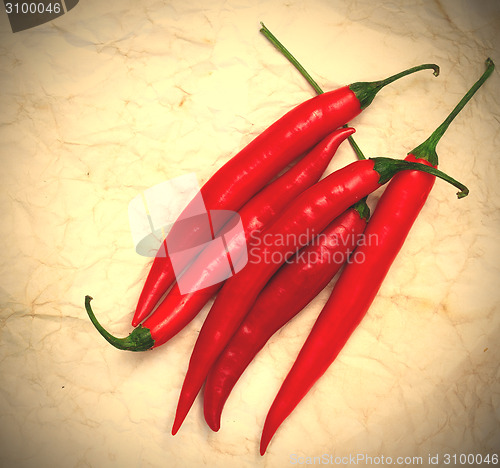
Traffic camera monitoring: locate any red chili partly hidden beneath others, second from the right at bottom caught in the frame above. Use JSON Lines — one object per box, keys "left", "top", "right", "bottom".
{"left": 203, "top": 200, "right": 370, "bottom": 431}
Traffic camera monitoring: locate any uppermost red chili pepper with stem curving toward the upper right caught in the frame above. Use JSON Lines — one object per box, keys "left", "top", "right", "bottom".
{"left": 132, "top": 64, "right": 439, "bottom": 326}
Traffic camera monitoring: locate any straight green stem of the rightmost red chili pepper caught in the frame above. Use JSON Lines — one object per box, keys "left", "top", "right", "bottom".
{"left": 409, "top": 58, "right": 495, "bottom": 166}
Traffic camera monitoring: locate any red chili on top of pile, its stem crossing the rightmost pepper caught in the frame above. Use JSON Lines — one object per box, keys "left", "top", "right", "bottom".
{"left": 172, "top": 158, "right": 468, "bottom": 434}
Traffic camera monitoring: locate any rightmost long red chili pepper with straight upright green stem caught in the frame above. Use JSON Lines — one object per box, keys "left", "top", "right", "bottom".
{"left": 260, "top": 59, "right": 494, "bottom": 454}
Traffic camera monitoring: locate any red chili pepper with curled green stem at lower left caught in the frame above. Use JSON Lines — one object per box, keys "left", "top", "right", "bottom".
{"left": 87, "top": 128, "right": 354, "bottom": 351}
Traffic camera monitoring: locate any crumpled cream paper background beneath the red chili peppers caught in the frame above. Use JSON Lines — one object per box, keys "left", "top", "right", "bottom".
{"left": 0, "top": 0, "right": 500, "bottom": 467}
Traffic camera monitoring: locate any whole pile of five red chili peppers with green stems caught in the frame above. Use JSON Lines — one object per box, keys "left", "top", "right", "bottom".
{"left": 85, "top": 25, "right": 494, "bottom": 454}
